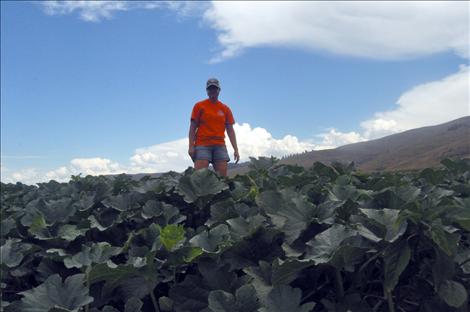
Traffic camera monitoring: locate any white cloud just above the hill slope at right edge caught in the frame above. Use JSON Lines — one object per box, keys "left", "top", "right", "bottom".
{"left": 361, "top": 66, "right": 470, "bottom": 139}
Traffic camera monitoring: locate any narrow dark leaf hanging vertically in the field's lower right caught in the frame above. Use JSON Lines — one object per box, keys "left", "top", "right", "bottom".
{"left": 383, "top": 240, "right": 411, "bottom": 292}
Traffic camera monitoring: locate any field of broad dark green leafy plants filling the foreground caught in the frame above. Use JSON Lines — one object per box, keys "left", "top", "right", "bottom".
{"left": 0, "top": 158, "right": 470, "bottom": 312}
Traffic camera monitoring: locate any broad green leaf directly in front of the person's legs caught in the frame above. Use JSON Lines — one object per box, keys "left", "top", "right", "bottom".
{"left": 176, "top": 168, "right": 228, "bottom": 203}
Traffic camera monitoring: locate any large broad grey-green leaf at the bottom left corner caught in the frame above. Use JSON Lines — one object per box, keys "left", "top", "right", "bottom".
{"left": 19, "top": 274, "right": 93, "bottom": 312}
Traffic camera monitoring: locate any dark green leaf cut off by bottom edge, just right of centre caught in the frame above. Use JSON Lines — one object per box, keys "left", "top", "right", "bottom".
{"left": 259, "top": 285, "right": 315, "bottom": 312}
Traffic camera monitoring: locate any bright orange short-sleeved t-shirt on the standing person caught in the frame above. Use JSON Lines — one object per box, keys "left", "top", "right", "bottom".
{"left": 191, "top": 99, "right": 235, "bottom": 146}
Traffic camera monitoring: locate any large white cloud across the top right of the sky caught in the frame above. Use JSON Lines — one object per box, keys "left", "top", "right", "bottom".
{"left": 204, "top": 1, "right": 470, "bottom": 62}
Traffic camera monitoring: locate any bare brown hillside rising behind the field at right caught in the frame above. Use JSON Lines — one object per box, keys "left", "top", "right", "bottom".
{"left": 228, "top": 116, "right": 470, "bottom": 176}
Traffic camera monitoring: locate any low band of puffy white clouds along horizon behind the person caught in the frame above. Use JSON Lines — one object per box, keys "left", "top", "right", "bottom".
{"left": 2, "top": 123, "right": 328, "bottom": 184}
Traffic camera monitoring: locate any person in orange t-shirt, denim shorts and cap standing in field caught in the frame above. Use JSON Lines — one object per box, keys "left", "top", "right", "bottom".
{"left": 188, "top": 78, "right": 240, "bottom": 177}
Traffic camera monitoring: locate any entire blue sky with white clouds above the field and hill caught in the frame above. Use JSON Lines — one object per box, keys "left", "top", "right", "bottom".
{"left": 1, "top": 1, "right": 469, "bottom": 183}
